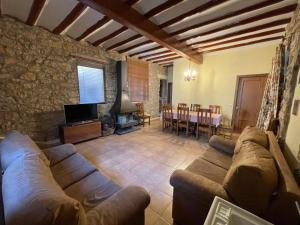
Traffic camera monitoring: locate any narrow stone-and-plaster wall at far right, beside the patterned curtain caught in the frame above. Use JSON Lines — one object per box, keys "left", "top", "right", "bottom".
{"left": 278, "top": 3, "right": 300, "bottom": 169}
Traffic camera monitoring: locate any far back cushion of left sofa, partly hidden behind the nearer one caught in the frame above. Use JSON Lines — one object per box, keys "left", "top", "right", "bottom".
{"left": 0, "top": 131, "right": 49, "bottom": 171}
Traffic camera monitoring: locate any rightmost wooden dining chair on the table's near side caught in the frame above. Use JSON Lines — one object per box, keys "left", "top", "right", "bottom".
{"left": 196, "top": 109, "right": 213, "bottom": 139}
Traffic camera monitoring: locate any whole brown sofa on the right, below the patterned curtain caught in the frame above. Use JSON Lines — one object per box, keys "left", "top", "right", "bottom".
{"left": 170, "top": 127, "right": 300, "bottom": 225}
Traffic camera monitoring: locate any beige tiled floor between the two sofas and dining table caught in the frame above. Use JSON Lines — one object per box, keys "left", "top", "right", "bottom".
{"left": 76, "top": 120, "right": 208, "bottom": 225}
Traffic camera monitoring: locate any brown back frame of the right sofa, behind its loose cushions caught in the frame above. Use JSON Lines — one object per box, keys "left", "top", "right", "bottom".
{"left": 267, "top": 131, "right": 300, "bottom": 225}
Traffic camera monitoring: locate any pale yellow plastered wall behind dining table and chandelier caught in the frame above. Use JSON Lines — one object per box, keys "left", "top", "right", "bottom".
{"left": 173, "top": 43, "right": 278, "bottom": 122}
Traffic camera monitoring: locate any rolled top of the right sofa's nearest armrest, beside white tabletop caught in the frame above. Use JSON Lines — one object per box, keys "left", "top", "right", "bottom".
{"left": 170, "top": 170, "right": 229, "bottom": 200}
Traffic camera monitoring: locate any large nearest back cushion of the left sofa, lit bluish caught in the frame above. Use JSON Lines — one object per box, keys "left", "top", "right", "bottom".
{"left": 2, "top": 155, "right": 85, "bottom": 225}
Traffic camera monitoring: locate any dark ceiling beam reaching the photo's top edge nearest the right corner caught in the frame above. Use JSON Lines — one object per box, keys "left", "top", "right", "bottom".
{"left": 170, "top": 0, "right": 284, "bottom": 35}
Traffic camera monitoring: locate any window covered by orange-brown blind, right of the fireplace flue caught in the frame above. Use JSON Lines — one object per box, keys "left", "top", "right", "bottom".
{"left": 127, "top": 59, "right": 149, "bottom": 102}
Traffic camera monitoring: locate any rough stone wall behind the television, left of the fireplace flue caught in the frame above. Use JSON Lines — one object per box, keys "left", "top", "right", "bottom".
{"left": 0, "top": 17, "right": 122, "bottom": 141}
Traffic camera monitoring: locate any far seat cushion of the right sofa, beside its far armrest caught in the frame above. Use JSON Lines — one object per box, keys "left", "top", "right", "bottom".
{"left": 200, "top": 148, "right": 232, "bottom": 170}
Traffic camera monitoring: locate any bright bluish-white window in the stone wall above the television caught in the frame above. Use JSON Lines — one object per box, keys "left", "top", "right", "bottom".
{"left": 77, "top": 66, "right": 105, "bottom": 103}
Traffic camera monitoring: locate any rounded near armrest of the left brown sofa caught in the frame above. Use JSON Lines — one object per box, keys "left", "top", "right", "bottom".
{"left": 87, "top": 186, "right": 150, "bottom": 225}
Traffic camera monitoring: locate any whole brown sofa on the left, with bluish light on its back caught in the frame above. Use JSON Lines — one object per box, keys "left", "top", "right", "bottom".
{"left": 0, "top": 132, "right": 150, "bottom": 225}
